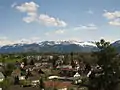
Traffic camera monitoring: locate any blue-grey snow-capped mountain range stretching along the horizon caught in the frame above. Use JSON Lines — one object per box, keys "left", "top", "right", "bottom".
{"left": 0, "top": 40, "right": 120, "bottom": 53}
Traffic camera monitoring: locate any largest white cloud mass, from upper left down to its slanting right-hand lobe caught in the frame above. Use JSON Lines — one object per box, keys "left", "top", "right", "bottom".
{"left": 15, "top": 2, "right": 67, "bottom": 27}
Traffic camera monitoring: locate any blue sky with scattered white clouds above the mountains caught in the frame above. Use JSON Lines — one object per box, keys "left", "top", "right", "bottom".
{"left": 0, "top": 0, "right": 120, "bottom": 45}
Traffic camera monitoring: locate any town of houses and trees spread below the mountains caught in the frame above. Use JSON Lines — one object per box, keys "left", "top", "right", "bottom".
{"left": 0, "top": 53, "right": 103, "bottom": 90}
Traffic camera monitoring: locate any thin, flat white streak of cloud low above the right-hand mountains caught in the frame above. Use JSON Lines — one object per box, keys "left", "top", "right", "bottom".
{"left": 74, "top": 24, "right": 98, "bottom": 30}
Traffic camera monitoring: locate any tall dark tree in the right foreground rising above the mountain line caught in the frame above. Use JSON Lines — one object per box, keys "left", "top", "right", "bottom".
{"left": 89, "top": 39, "right": 120, "bottom": 90}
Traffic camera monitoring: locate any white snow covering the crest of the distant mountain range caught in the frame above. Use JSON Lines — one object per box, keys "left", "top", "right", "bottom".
{"left": 0, "top": 40, "right": 96, "bottom": 47}
